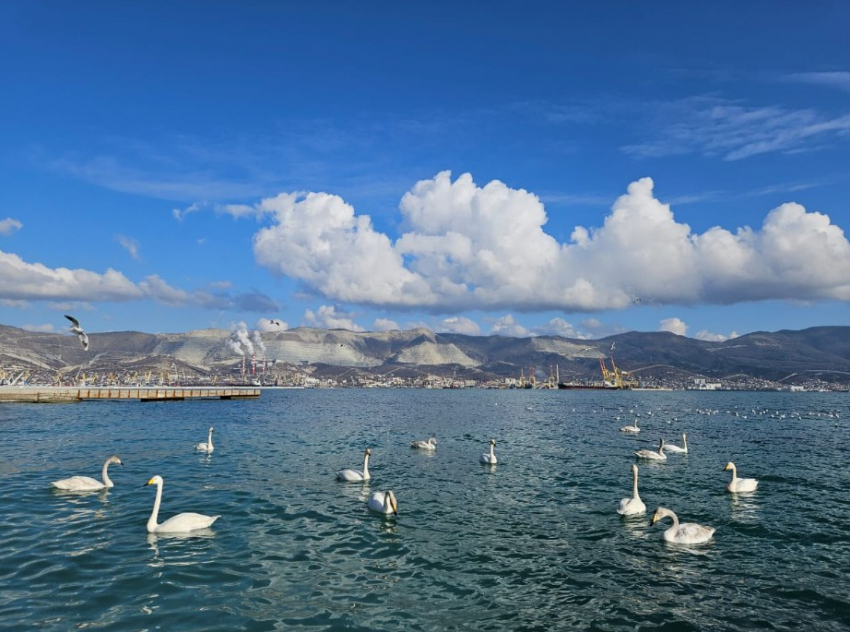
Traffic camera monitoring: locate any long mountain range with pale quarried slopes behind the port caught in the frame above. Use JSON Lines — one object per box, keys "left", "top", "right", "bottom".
{"left": 0, "top": 325, "right": 850, "bottom": 384}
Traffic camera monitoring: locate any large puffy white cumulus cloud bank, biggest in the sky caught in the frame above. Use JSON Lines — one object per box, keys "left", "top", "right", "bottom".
{"left": 230, "top": 171, "right": 850, "bottom": 312}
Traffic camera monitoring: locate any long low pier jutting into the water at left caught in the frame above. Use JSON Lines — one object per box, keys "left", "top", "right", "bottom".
{"left": 0, "top": 386, "right": 261, "bottom": 403}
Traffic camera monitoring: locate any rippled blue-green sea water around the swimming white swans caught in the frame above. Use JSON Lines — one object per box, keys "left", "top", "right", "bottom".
{"left": 0, "top": 390, "right": 850, "bottom": 631}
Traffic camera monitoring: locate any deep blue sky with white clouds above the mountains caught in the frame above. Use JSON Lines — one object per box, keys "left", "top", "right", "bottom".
{"left": 0, "top": 0, "right": 850, "bottom": 341}
